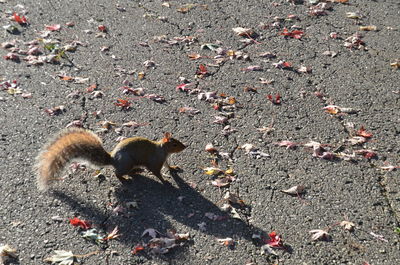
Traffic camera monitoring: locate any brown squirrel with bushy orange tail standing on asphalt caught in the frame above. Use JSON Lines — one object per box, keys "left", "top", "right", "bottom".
{"left": 34, "top": 128, "right": 186, "bottom": 190}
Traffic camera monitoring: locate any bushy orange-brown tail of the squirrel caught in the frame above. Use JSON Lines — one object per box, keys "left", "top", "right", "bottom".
{"left": 35, "top": 128, "right": 112, "bottom": 190}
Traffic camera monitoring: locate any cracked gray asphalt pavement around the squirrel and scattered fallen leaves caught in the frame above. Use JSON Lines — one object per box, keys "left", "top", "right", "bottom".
{"left": 0, "top": 0, "right": 400, "bottom": 265}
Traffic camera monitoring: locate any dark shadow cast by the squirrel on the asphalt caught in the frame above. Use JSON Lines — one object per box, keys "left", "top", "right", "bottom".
{"left": 53, "top": 172, "right": 267, "bottom": 258}
